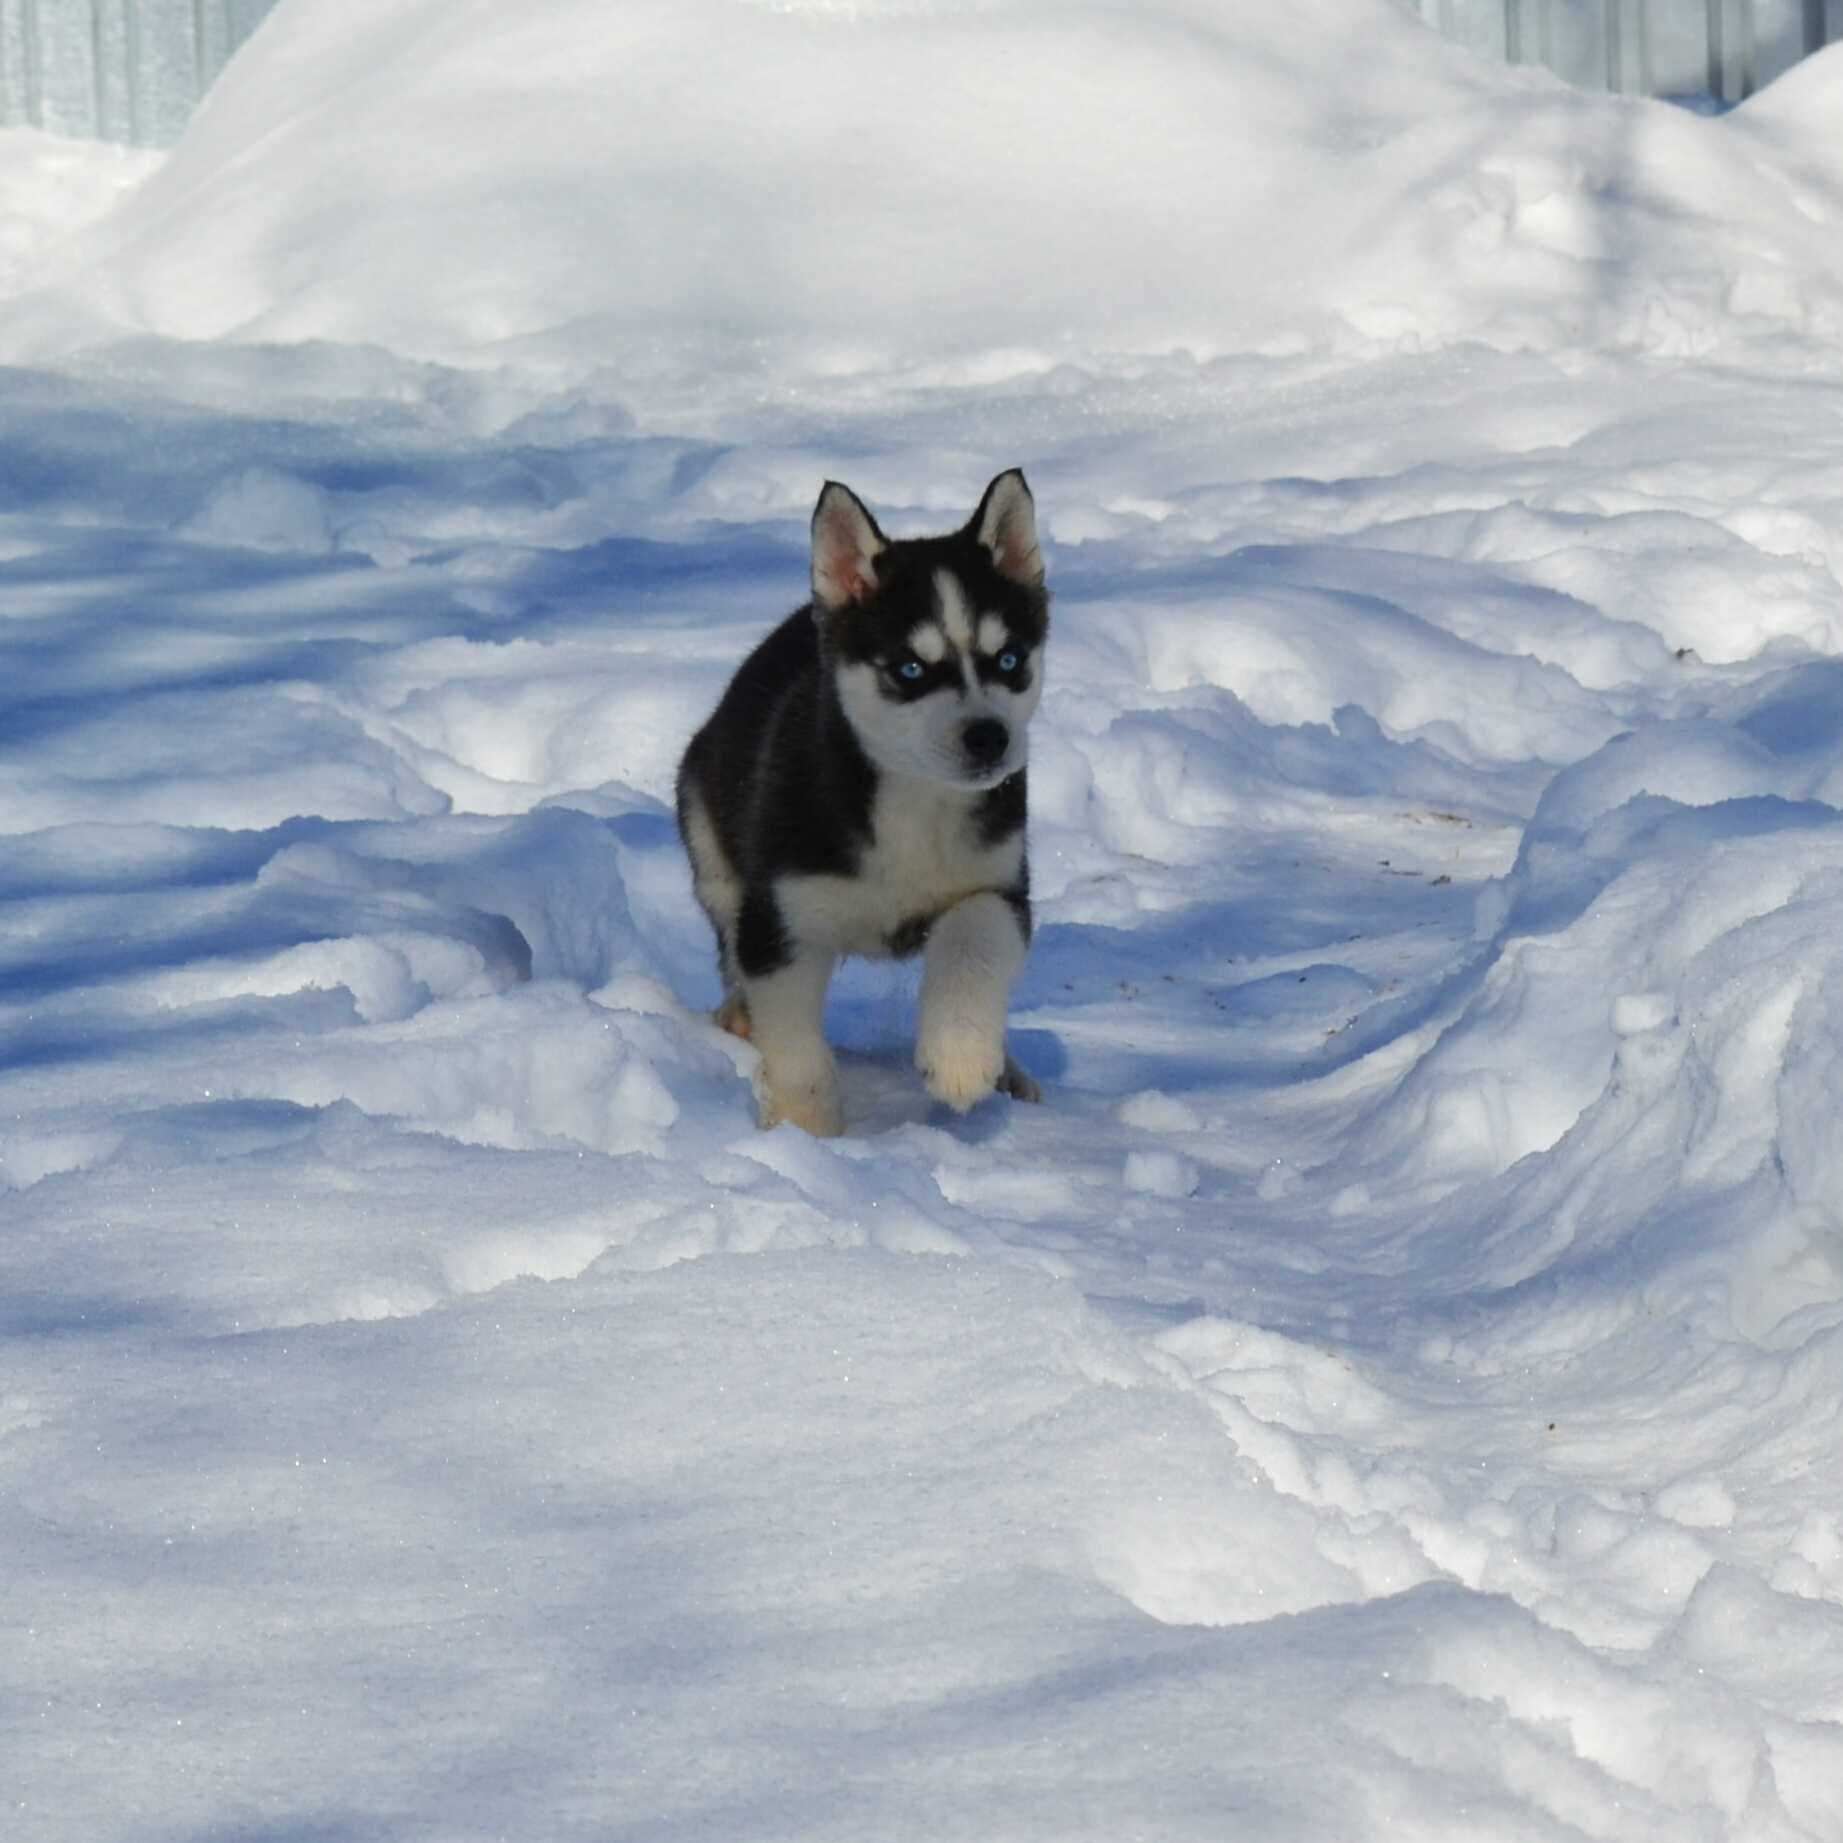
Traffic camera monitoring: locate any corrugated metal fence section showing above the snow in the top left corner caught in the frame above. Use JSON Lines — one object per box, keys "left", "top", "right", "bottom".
{"left": 0, "top": 0, "right": 276, "bottom": 147}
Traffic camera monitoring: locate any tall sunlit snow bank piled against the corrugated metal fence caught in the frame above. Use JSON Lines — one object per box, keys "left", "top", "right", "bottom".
{"left": 4, "top": 0, "right": 1843, "bottom": 374}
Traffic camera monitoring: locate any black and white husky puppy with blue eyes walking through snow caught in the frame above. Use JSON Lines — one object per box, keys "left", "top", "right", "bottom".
{"left": 678, "top": 468, "right": 1049, "bottom": 1133}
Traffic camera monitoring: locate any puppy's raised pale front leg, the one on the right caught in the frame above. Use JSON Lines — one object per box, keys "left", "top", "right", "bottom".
{"left": 916, "top": 890, "right": 1036, "bottom": 1113}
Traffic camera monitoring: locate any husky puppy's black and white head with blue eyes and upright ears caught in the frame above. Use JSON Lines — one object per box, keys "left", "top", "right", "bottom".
{"left": 813, "top": 468, "right": 1049, "bottom": 792}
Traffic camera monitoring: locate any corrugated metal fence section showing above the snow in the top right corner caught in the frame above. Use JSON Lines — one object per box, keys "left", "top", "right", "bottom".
{"left": 1414, "top": 0, "right": 1843, "bottom": 103}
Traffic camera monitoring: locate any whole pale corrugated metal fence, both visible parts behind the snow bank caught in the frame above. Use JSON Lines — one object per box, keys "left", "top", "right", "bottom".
{"left": 0, "top": 0, "right": 1843, "bottom": 147}
